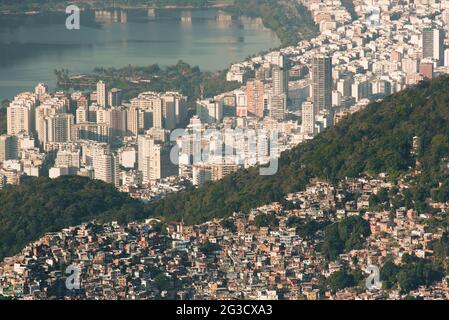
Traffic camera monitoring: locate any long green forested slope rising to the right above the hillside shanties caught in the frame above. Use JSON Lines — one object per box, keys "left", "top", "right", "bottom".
{"left": 150, "top": 76, "right": 449, "bottom": 223}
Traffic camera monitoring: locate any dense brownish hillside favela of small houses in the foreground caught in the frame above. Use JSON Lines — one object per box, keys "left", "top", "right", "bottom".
{"left": 0, "top": 168, "right": 449, "bottom": 300}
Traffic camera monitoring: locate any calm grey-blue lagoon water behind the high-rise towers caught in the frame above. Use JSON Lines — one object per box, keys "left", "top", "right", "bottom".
{"left": 0, "top": 9, "right": 280, "bottom": 101}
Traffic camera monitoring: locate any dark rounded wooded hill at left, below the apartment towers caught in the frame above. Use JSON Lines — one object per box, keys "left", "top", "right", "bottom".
{"left": 0, "top": 176, "right": 149, "bottom": 259}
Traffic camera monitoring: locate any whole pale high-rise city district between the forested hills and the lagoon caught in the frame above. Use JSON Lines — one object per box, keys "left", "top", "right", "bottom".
{"left": 6, "top": 0, "right": 449, "bottom": 196}
